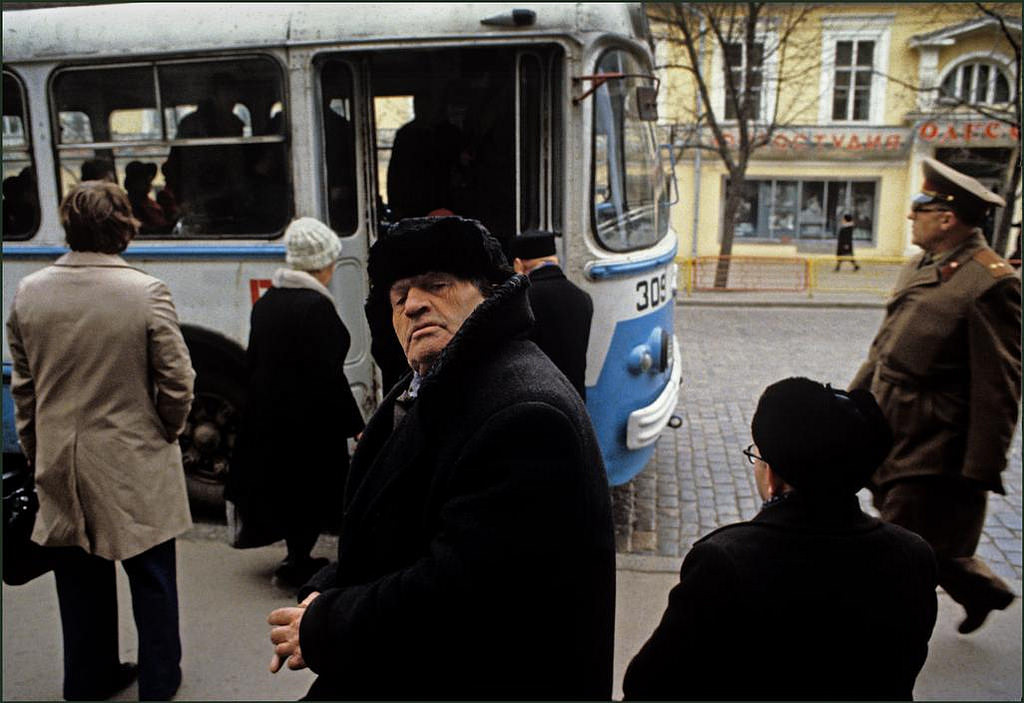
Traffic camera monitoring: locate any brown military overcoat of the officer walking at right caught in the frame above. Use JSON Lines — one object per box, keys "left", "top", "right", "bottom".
{"left": 851, "top": 231, "right": 1021, "bottom": 493}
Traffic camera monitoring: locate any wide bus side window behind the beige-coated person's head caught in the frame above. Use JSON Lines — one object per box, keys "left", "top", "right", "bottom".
{"left": 53, "top": 57, "right": 292, "bottom": 237}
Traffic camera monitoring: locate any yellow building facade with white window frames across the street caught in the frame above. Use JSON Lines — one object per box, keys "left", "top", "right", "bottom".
{"left": 651, "top": 3, "right": 1021, "bottom": 257}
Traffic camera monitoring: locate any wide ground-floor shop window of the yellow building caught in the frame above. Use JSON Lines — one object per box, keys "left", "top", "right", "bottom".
{"left": 735, "top": 179, "right": 878, "bottom": 243}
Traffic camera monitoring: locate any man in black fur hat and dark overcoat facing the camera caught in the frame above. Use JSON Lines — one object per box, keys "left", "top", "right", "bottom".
{"left": 269, "top": 217, "right": 615, "bottom": 700}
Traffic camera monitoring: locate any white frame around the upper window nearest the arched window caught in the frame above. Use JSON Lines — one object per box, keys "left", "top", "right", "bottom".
{"left": 818, "top": 14, "right": 895, "bottom": 125}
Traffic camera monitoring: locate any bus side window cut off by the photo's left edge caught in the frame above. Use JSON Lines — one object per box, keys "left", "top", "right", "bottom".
{"left": 3, "top": 71, "right": 39, "bottom": 240}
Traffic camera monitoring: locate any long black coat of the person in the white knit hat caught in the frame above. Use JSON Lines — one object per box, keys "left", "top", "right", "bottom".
{"left": 226, "top": 280, "right": 364, "bottom": 536}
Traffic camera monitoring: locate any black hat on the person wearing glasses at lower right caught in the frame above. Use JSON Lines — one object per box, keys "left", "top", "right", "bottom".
{"left": 751, "top": 378, "right": 893, "bottom": 493}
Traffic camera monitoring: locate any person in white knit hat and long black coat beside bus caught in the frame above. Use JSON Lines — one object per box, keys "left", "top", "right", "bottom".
{"left": 226, "top": 217, "right": 362, "bottom": 586}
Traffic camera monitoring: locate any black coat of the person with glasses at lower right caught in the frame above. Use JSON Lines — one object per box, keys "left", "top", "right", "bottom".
{"left": 623, "top": 493, "right": 936, "bottom": 700}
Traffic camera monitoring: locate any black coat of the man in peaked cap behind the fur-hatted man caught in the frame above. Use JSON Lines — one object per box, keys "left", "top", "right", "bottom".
{"left": 529, "top": 264, "right": 594, "bottom": 400}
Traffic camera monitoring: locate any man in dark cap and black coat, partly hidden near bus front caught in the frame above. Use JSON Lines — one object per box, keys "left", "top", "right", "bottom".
{"left": 512, "top": 229, "right": 594, "bottom": 401}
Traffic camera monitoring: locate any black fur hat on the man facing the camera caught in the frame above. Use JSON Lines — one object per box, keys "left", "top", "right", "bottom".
{"left": 367, "top": 217, "right": 515, "bottom": 306}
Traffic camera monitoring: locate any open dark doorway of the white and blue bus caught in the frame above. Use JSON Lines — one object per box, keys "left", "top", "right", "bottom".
{"left": 321, "top": 45, "right": 562, "bottom": 393}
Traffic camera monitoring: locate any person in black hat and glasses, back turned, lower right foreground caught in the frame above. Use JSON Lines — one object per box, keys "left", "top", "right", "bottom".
{"left": 623, "top": 379, "right": 937, "bottom": 700}
